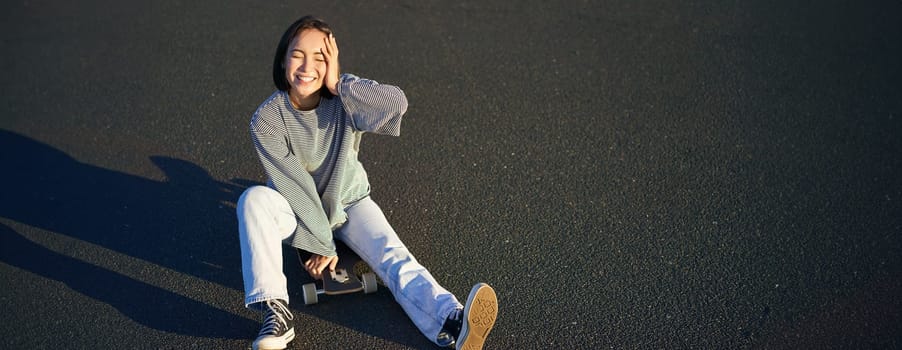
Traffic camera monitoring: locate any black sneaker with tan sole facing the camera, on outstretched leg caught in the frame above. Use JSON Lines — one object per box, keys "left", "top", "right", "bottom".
{"left": 439, "top": 283, "right": 498, "bottom": 350}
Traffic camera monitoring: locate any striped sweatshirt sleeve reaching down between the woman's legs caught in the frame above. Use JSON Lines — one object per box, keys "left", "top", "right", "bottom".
{"left": 251, "top": 116, "right": 336, "bottom": 256}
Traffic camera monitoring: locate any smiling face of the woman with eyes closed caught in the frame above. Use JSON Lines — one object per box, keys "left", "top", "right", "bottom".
{"left": 282, "top": 29, "right": 327, "bottom": 110}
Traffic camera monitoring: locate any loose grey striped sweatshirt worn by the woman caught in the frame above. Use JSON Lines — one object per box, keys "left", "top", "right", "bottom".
{"left": 250, "top": 74, "right": 407, "bottom": 256}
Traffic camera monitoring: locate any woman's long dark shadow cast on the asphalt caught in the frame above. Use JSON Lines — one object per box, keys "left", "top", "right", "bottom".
{"left": 0, "top": 130, "right": 259, "bottom": 339}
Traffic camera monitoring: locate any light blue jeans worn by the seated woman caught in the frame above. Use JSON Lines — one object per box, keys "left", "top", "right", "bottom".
{"left": 237, "top": 186, "right": 463, "bottom": 345}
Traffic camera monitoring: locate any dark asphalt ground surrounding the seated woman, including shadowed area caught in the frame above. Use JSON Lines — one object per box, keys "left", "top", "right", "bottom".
{"left": 0, "top": 0, "right": 902, "bottom": 349}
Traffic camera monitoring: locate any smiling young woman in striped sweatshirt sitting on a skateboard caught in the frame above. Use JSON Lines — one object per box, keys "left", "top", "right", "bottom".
{"left": 237, "top": 16, "right": 498, "bottom": 349}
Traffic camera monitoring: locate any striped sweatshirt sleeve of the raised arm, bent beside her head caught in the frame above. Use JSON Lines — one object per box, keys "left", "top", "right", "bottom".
{"left": 338, "top": 74, "right": 407, "bottom": 136}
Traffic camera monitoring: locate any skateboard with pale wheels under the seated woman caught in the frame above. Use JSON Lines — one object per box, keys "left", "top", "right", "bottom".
{"left": 297, "top": 241, "right": 378, "bottom": 305}
